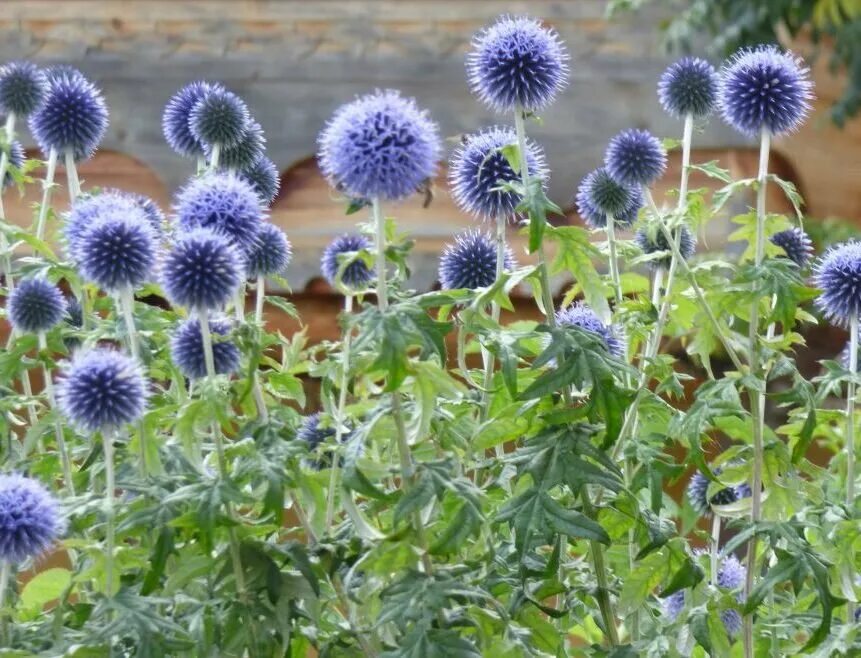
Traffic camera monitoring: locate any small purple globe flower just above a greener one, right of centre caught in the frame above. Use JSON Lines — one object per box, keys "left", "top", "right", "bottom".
{"left": 604, "top": 128, "right": 667, "bottom": 186}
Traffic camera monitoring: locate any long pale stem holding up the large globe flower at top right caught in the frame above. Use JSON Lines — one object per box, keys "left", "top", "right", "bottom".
{"left": 743, "top": 130, "right": 771, "bottom": 658}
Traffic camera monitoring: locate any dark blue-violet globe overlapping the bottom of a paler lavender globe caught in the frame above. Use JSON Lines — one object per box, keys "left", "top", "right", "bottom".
{"left": 162, "top": 229, "right": 244, "bottom": 312}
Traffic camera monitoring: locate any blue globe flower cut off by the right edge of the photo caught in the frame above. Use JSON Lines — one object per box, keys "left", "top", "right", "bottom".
{"left": 814, "top": 240, "right": 861, "bottom": 326}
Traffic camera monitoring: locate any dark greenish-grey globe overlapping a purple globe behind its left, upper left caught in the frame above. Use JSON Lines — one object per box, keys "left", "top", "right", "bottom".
{"left": 188, "top": 87, "right": 251, "bottom": 149}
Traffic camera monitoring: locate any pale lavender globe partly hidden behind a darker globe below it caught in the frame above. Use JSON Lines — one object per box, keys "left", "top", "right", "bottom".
{"left": 174, "top": 172, "right": 265, "bottom": 254}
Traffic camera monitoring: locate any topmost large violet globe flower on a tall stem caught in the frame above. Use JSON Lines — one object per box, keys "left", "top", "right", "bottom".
{"left": 466, "top": 16, "right": 568, "bottom": 114}
